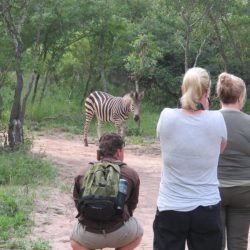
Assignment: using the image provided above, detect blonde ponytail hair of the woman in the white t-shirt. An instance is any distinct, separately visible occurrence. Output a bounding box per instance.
[181,67,211,110]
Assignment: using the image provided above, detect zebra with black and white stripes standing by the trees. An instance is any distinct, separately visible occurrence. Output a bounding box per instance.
[83,91,144,147]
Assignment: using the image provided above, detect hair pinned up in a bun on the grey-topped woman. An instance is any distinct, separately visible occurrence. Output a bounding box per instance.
[216,72,246,104]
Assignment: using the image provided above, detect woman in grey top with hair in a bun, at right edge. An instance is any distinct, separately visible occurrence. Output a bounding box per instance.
[217,73,250,250]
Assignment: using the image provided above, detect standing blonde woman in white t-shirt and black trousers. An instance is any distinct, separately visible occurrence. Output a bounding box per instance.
[153,67,227,250]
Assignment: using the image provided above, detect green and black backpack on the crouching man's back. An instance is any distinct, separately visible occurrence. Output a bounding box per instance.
[78,162,120,221]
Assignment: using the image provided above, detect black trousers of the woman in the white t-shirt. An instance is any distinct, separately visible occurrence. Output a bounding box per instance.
[153,203,222,250]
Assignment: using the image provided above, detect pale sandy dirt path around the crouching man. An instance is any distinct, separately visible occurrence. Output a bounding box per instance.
[31,133,161,250]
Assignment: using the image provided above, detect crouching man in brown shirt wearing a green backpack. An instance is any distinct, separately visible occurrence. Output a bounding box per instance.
[70,133,143,250]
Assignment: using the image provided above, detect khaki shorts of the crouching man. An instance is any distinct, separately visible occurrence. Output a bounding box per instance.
[70,217,143,249]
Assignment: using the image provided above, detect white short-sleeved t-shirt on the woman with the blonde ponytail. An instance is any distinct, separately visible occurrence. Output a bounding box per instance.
[157,108,227,211]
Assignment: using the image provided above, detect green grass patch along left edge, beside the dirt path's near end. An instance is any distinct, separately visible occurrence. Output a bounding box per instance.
[0,146,55,244]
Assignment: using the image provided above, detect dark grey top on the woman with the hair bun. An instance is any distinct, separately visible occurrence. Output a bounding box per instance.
[218,109,250,187]
